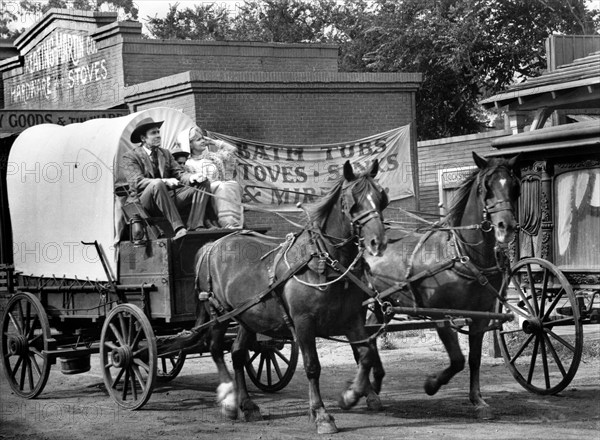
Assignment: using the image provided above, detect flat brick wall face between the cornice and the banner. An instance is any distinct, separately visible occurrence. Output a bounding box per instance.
[195,92,411,144]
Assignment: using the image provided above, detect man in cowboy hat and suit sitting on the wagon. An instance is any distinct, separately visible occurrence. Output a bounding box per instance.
[123,118,208,239]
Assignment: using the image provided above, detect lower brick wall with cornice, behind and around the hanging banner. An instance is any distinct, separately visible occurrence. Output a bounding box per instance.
[126,71,420,236]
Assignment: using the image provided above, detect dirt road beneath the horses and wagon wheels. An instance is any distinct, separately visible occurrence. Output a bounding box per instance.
[0,338,600,440]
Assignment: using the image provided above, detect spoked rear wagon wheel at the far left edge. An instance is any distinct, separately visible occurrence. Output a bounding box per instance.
[0,293,51,399]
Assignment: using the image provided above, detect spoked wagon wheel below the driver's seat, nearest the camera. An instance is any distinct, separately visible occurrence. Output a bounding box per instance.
[100,304,157,410]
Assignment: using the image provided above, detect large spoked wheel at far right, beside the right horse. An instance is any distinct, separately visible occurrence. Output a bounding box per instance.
[496,258,583,394]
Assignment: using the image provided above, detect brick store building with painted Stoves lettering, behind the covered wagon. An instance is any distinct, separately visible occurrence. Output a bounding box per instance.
[0,9,421,254]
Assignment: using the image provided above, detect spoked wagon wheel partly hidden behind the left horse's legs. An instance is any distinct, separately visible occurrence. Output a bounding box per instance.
[246,339,298,393]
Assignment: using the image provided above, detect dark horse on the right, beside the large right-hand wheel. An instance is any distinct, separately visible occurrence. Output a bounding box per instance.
[366,153,520,418]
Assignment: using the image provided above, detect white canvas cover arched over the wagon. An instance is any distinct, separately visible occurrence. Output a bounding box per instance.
[7,107,195,281]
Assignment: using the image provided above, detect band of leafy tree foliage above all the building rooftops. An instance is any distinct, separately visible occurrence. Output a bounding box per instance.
[5,0,600,139]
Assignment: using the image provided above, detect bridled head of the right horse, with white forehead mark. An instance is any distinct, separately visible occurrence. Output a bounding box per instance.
[473,152,521,243]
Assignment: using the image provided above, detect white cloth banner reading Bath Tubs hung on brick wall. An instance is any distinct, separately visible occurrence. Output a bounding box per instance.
[212,125,414,209]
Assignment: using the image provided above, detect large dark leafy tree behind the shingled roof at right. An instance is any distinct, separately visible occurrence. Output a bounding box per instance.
[332,0,598,139]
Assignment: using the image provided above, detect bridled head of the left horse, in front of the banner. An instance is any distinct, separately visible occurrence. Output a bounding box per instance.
[341,160,388,256]
